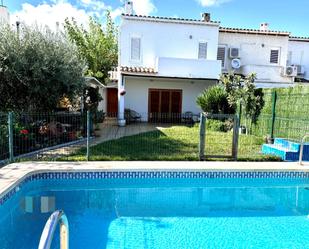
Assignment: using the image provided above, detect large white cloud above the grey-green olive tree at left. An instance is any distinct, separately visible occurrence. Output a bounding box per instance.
[11,0,89,29]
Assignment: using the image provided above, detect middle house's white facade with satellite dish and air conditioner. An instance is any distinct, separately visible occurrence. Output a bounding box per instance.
[218,24,294,83]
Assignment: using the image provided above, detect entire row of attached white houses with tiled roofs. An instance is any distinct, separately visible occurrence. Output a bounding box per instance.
[105,1,309,125]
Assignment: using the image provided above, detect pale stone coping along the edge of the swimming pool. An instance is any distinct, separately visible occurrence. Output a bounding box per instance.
[0,161,309,198]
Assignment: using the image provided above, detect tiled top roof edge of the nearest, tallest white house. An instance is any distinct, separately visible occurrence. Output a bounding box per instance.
[122,14,220,25]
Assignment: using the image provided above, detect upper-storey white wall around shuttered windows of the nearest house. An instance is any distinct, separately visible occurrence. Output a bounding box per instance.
[119,17,218,78]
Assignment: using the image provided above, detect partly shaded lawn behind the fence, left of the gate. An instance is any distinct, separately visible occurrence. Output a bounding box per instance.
[68,130,198,161]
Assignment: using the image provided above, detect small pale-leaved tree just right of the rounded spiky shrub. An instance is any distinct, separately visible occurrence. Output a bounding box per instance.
[220,73,264,123]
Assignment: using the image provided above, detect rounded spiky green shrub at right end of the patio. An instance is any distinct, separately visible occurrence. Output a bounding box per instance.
[196,85,235,114]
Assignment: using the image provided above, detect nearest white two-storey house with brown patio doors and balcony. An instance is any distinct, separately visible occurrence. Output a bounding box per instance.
[114,6,221,124]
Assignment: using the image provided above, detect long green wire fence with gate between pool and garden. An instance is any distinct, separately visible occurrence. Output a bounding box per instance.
[0,106,309,163]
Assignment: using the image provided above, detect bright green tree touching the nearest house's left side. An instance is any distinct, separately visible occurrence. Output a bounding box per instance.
[65,11,118,83]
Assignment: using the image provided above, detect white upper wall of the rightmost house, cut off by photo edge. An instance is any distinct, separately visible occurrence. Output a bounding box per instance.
[289,41,309,80]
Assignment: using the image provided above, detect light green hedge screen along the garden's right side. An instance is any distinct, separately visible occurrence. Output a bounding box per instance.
[241,86,309,141]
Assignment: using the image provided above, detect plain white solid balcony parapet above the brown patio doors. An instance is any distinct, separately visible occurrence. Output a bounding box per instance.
[157,57,221,79]
